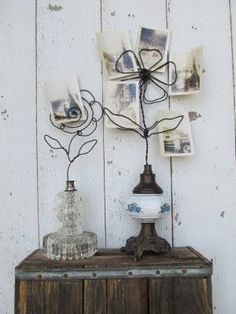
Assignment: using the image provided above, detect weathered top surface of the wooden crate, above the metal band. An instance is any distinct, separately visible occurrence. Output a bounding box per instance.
[16,248,211,272]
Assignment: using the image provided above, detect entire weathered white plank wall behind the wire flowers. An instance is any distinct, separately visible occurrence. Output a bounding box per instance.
[0,0,236,314]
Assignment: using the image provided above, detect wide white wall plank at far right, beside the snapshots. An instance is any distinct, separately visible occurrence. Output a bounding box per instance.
[169,0,236,314]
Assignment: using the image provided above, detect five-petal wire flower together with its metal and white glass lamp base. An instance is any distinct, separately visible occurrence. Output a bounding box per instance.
[101,49,184,260]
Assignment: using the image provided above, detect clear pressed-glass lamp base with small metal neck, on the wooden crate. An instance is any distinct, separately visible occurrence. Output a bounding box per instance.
[43,181,97,260]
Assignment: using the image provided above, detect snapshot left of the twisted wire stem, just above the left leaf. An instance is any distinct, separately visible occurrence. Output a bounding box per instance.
[105,81,139,129]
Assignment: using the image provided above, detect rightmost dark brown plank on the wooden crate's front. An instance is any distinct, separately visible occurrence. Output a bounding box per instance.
[149,277,212,314]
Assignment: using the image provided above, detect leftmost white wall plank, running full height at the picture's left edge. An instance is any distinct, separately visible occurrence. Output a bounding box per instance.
[0,0,38,314]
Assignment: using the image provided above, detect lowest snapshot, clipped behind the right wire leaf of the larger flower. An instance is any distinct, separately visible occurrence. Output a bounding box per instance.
[158,110,194,157]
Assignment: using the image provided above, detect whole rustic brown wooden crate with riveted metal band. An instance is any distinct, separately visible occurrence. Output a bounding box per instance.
[15,247,212,314]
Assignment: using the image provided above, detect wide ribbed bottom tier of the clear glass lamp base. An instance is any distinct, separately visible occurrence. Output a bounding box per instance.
[43,231,97,260]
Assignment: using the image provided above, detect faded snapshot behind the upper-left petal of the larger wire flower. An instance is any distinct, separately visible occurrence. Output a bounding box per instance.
[97,31,137,79]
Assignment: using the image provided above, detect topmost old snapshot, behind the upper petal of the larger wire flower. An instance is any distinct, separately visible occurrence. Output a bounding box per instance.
[137,27,170,72]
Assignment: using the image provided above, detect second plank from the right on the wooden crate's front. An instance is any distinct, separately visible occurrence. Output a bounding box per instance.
[107,279,148,314]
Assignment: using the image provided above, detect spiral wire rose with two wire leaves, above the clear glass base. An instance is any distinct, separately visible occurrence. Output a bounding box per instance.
[44,89,103,181]
